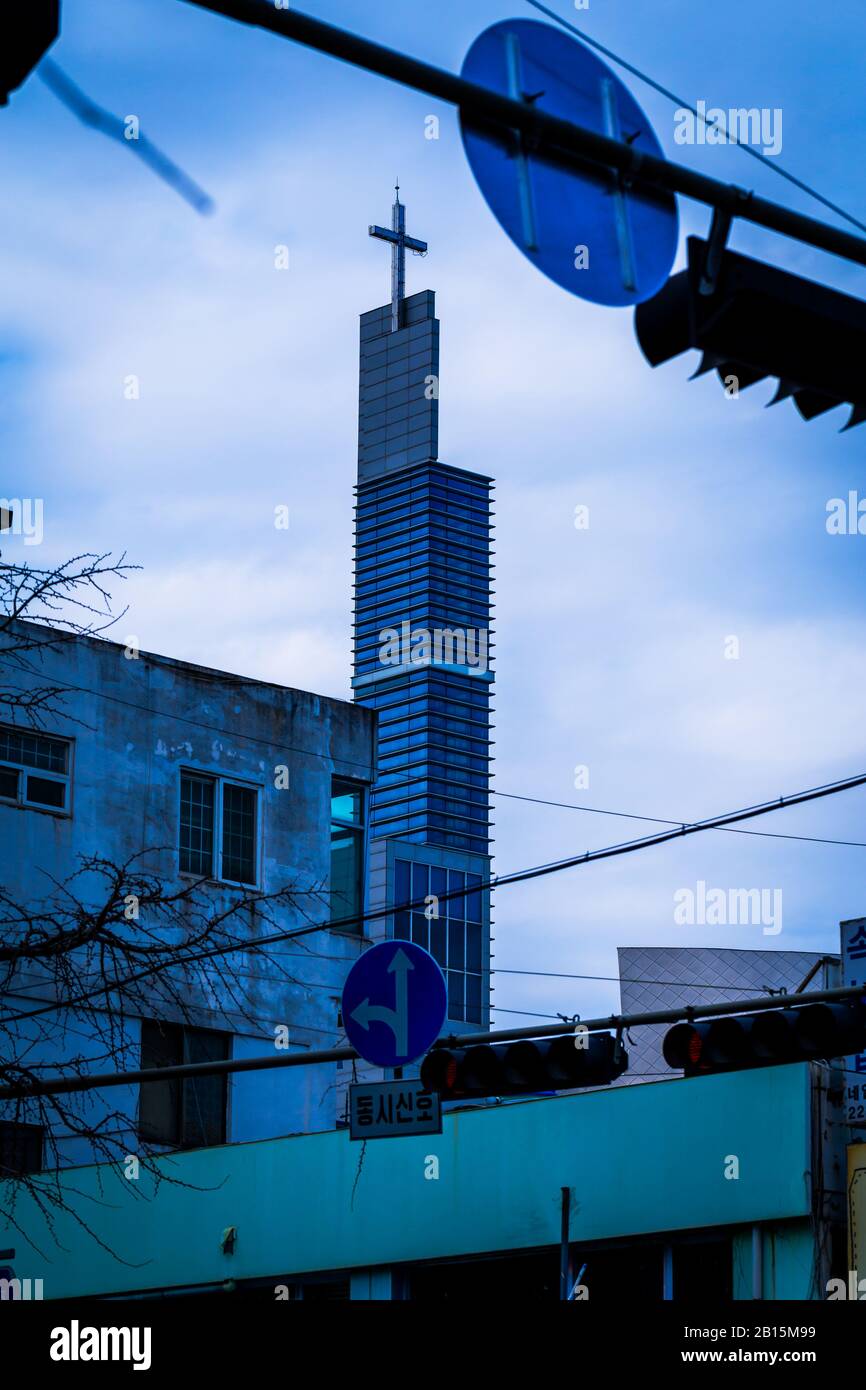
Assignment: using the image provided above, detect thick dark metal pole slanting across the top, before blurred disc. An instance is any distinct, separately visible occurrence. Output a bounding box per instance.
[177,0,866,265]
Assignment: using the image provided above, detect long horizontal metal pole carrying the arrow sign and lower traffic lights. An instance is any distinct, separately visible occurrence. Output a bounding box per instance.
[0,986,866,1101]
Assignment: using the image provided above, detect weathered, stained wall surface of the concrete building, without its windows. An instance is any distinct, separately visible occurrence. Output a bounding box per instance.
[0,622,375,1162]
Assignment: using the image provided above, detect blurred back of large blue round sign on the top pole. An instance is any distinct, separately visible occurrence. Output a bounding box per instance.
[460,19,678,306]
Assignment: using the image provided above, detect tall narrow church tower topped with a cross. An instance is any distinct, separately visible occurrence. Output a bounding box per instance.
[352,188,493,1030]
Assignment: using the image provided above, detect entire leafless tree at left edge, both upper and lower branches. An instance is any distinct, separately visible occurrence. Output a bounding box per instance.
[0,553,333,1264]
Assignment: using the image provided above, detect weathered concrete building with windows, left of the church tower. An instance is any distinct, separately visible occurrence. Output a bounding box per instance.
[0,630,375,1166]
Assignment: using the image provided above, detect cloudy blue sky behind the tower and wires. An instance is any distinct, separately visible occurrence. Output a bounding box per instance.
[0,0,866,1022]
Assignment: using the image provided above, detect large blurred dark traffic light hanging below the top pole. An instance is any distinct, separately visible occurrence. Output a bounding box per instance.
[635,236,866,430]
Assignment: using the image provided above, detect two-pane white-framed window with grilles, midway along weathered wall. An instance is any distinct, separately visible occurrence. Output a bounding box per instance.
[179,771,259,884]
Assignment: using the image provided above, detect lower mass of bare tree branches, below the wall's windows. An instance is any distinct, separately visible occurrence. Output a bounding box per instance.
[0,852,324,1259]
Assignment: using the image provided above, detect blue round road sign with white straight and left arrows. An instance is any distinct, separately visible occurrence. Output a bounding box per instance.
[342,941,448,1066]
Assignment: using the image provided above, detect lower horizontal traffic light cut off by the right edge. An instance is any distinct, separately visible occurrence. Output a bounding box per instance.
[662,999,866,1076]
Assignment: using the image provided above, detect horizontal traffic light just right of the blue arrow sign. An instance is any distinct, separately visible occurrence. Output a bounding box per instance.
[421,1029,628,1101]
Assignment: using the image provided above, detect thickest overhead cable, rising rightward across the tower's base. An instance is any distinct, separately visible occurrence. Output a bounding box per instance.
[6,773,866,1022]
